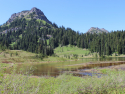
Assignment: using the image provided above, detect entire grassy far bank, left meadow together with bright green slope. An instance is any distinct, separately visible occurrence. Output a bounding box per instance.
[0,45,122,65]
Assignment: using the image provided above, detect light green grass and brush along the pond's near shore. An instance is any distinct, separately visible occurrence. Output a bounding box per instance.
[0,70,125,94]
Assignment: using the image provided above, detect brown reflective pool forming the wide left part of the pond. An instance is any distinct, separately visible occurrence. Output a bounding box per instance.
[4,64,60,76]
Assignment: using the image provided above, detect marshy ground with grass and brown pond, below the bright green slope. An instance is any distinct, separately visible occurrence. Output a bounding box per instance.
[0,50,125,94]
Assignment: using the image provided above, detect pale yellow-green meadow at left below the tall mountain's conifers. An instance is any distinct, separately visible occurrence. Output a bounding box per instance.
[0,50,41,63]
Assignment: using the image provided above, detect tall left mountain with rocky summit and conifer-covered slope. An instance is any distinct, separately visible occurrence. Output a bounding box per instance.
[0,7,57,55]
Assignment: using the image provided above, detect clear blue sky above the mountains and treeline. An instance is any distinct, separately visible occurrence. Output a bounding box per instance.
[0,0,125,33]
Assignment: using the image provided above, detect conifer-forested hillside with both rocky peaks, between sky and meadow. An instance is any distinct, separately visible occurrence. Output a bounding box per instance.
[0,7,125,58]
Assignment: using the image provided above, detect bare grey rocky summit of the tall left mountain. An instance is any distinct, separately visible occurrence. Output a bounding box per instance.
[7,7,51,24]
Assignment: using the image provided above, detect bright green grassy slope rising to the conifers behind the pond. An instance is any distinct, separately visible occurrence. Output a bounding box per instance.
[43,45,93,61]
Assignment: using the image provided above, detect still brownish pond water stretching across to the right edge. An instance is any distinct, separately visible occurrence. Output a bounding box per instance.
[4,57,125,77]
